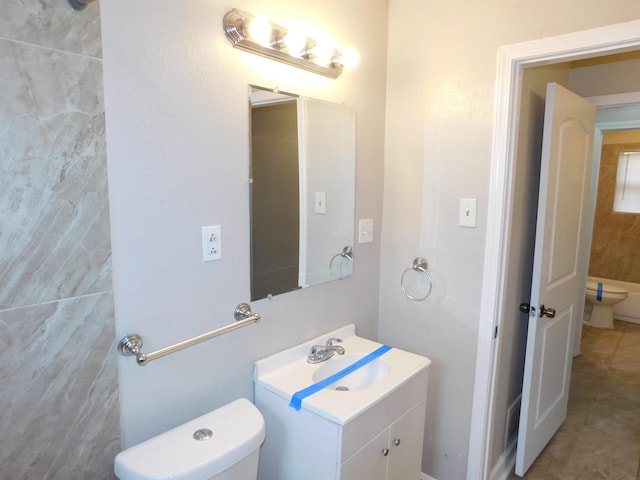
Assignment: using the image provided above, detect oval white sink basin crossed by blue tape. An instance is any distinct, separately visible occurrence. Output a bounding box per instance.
[312,353,391,392]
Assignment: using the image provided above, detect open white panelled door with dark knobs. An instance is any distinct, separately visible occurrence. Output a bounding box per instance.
[516,83,596,476]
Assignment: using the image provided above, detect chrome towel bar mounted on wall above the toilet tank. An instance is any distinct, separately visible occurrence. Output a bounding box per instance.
[118,303,260,365]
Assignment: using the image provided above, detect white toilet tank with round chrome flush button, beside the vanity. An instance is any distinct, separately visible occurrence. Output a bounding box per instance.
[114,398,265,480]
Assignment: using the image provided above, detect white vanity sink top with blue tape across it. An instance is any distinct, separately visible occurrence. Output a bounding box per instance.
[254,324,431,425]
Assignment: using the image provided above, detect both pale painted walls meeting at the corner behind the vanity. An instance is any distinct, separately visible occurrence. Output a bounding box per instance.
[101,0,640,474]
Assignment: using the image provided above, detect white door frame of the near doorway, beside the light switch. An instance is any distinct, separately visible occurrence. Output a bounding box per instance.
[467,20,640,480]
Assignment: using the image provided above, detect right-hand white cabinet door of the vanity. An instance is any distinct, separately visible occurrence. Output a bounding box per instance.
[387,399,427,480]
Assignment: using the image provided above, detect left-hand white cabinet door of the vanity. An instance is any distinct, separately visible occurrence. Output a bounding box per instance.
[340,429,390,480]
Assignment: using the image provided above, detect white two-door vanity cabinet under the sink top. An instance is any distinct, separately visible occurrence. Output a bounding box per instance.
[255,368,428,480]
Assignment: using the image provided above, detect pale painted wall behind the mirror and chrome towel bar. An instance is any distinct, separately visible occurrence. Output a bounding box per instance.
[101,0,387,446]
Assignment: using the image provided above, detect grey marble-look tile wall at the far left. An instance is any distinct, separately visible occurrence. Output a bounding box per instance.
[0,0,120,480]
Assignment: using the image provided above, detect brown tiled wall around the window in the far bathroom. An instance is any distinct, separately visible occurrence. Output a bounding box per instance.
[589,139,640,283]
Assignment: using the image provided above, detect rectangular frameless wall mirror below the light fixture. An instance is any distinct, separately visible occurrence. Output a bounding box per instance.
[249,86,355,301]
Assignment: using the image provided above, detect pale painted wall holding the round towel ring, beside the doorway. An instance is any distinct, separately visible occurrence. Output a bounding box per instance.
[380,0,640,480]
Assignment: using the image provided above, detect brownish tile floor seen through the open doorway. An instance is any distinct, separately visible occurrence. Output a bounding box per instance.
[509,321,640,480]
